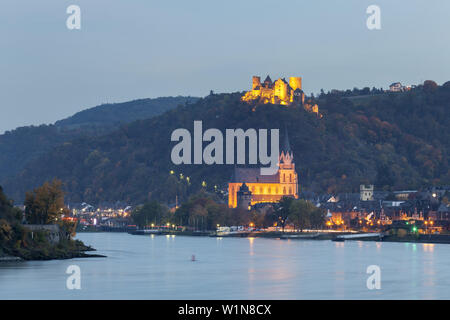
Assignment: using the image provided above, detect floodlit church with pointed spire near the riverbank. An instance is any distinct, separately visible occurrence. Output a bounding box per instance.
[228,132,298,209]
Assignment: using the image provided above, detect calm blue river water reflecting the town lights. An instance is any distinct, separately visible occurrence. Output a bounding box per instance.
[0,233,450,299]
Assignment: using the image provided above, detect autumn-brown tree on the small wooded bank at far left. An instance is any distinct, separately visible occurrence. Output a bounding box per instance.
[24,179,65,224]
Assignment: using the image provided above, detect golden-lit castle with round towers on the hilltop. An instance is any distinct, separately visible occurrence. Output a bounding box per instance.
[241,76,320,116]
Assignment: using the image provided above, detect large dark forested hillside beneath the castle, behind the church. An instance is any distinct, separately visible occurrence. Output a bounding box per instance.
[4,85,450,203]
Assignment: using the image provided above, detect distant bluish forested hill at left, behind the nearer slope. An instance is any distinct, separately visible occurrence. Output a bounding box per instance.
[0,96,198,183]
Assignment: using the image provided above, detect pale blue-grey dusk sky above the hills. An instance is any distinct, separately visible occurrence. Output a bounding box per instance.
[0,0,450,133]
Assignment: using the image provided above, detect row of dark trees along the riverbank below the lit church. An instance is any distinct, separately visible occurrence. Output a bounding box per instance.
[132,192,325,231]
